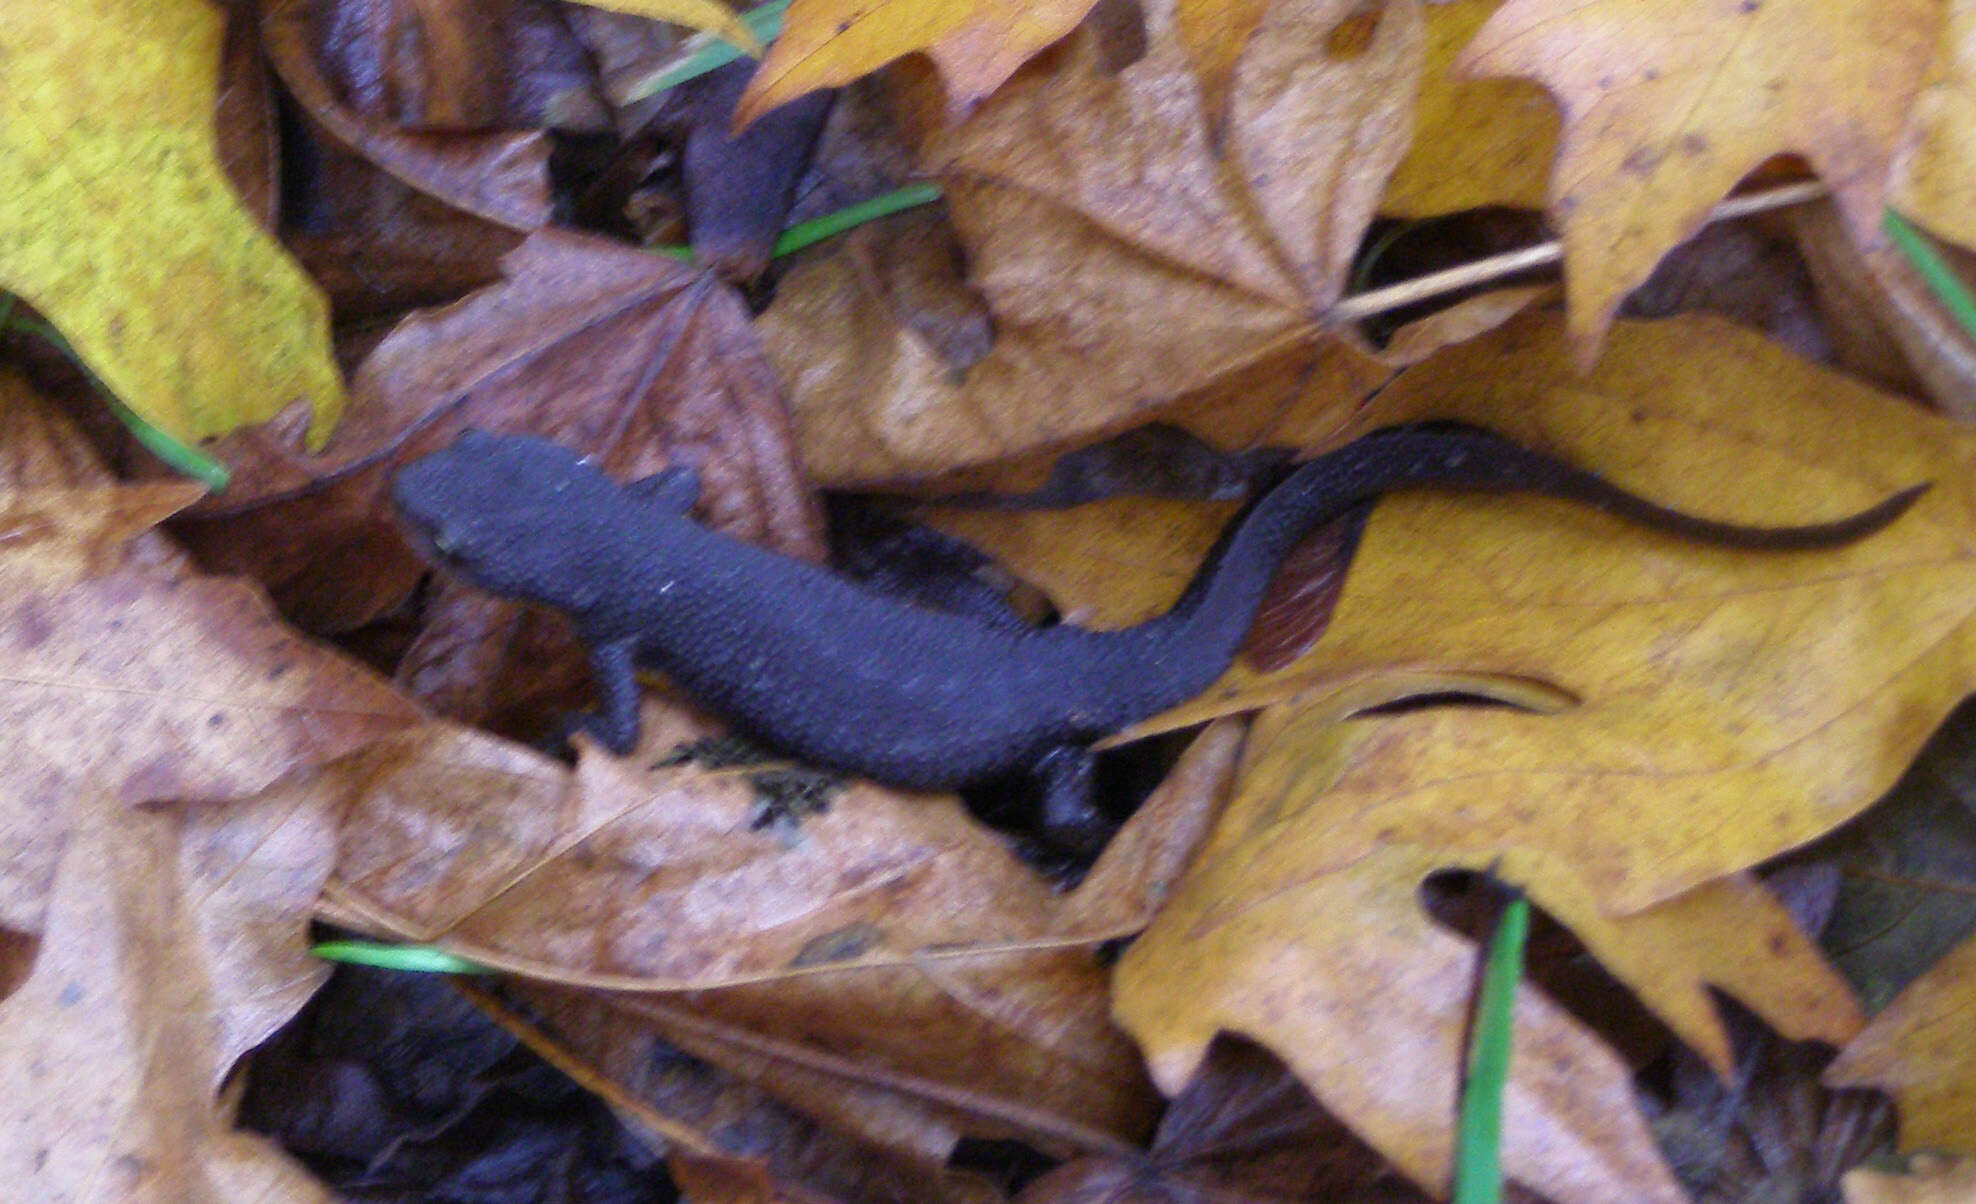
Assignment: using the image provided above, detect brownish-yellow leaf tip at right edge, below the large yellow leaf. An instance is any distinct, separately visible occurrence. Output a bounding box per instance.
[1826,925,1976,1155]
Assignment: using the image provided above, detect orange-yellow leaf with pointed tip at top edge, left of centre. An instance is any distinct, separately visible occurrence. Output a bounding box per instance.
[735,0,1097,125]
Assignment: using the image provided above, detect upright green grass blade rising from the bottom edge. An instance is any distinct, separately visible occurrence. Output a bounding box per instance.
[1454,894,1529,1204]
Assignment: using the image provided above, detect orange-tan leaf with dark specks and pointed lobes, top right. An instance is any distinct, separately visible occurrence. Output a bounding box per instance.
[1460,0,1942,366]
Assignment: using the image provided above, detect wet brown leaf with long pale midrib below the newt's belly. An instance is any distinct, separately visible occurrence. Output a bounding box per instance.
[326,706,1239,1149]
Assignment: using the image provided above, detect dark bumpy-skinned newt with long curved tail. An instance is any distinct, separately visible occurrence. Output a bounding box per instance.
[393,427,1927,836]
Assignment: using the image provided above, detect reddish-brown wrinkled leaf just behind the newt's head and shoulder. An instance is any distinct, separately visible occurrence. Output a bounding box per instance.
[354,231,822,558]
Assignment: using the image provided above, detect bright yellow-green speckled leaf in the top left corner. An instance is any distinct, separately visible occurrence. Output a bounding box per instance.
[0,0,342,439]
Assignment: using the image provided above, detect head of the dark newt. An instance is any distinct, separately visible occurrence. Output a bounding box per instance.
[391,429,624,605]
